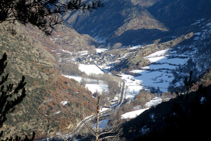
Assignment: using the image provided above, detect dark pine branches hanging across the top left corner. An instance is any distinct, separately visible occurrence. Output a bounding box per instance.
[0,0,104,35]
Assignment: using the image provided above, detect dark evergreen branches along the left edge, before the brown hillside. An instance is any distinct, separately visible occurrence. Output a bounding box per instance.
[0,53,35,141]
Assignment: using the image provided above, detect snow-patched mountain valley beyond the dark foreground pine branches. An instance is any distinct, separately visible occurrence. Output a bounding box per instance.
[0,0,211,140]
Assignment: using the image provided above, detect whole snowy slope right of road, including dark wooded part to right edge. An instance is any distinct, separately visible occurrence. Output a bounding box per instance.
[121,20,211,94]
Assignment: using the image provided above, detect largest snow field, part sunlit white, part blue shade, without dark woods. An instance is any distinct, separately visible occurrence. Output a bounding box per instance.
[118,49,191,98]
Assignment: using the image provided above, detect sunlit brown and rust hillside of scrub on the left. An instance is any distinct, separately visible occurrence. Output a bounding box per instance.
[0,23,95,138]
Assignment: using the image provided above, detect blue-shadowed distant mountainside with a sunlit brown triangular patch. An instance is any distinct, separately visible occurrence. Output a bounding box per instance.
[63,0,211,46]
